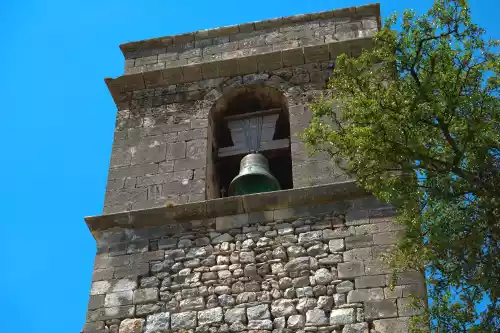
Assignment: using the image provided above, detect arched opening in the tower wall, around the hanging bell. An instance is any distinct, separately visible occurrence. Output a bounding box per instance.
[207,85,293,199]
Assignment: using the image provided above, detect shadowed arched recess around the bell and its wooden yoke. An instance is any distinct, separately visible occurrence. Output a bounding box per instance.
[206,82,293,199]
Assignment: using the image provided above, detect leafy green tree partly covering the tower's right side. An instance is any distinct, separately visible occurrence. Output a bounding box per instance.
[302,0,500,332]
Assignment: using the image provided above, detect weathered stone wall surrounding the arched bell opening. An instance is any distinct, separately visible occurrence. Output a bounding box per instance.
[104,61,345,213]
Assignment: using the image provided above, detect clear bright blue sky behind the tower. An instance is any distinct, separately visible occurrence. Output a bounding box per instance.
[0,0,500,333]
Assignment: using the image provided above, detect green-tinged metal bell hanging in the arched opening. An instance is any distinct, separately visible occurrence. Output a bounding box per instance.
[229,154,280,196]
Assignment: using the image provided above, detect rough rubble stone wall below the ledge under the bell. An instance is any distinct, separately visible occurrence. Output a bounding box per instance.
[83,197,425,333]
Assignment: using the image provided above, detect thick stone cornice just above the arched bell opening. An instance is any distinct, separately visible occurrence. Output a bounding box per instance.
[104,37,372,101]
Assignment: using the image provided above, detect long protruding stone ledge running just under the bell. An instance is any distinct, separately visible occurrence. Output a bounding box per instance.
[85,181,369,236]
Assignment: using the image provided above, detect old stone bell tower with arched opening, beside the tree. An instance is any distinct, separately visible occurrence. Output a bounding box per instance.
[83,4,425,333]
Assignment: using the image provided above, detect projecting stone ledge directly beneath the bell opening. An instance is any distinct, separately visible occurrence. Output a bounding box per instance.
[85,181,368,236]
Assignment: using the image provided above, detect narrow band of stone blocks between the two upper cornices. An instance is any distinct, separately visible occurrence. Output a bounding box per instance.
[124,11,378,74]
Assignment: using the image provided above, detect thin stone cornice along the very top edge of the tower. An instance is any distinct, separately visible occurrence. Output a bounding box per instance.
[120,3,380,55]
